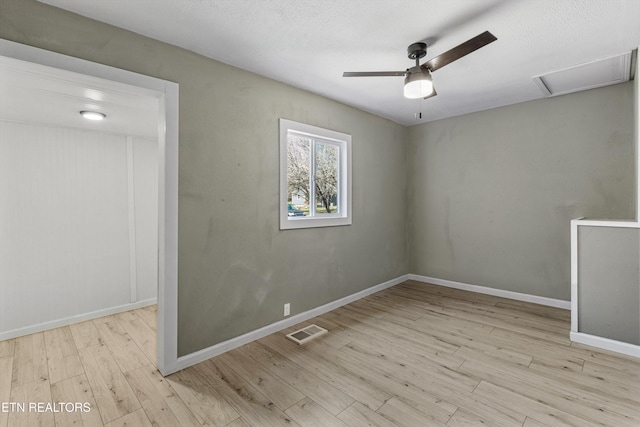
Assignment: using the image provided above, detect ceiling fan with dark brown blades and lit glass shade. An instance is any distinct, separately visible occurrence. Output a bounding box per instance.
[342,31,498,99]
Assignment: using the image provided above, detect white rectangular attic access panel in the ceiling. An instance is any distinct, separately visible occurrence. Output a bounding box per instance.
[531,51,634,97]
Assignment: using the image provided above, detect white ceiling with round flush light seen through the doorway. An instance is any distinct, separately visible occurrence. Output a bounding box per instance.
[0,57,159,138]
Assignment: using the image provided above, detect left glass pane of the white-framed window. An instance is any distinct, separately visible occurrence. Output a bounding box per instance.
[287,133,311,217]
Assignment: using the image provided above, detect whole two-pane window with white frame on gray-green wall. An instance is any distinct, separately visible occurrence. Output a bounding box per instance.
[280,119,351,230]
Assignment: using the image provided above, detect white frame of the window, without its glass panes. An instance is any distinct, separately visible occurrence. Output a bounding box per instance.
[280,119,351,230]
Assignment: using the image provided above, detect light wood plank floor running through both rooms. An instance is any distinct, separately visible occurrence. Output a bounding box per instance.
[0,281,640,427]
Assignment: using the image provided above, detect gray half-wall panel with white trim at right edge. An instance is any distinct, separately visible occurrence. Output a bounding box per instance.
[578,226,640,345]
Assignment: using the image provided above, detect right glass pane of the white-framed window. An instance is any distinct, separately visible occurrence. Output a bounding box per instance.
[315,142,339,215]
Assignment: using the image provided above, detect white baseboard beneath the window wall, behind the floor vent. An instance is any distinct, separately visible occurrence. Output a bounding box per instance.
[170,274,409,375]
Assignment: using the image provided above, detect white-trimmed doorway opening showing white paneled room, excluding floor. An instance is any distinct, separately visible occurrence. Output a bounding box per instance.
[0,40,178,375]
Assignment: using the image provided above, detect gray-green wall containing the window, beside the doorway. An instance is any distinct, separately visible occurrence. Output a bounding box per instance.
[0,0,409,355]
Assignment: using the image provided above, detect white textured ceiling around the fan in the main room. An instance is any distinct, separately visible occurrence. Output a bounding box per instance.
[28,0,640,125]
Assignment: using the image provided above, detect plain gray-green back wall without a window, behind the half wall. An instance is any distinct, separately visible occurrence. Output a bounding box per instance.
[408,83,635,300]
